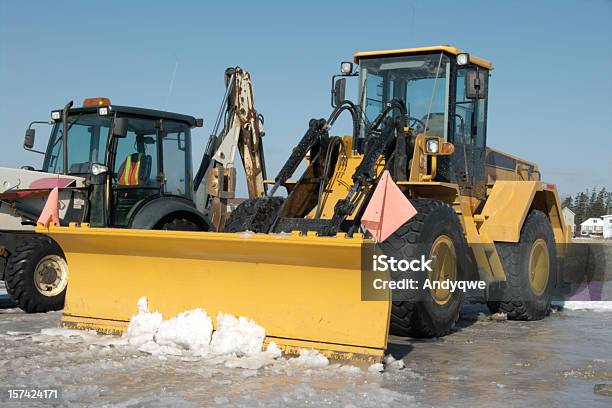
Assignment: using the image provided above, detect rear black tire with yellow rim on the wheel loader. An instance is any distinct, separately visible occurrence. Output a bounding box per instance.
[488,210,558,320]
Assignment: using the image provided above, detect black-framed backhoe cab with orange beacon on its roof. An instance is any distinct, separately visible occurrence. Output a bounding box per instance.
[43,98,201,227]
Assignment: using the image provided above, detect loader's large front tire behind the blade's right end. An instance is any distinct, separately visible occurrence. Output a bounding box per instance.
[381,199,467,338]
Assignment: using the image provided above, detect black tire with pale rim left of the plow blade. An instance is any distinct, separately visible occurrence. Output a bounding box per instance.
[5,236,68,313]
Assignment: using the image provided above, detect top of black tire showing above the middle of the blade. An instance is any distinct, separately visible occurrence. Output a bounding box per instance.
[224,197,285,233]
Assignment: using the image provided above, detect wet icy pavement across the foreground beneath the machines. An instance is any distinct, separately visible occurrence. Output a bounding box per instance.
[0,286,612,408]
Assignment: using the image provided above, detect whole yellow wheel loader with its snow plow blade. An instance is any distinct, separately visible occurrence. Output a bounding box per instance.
[40,46,569,362]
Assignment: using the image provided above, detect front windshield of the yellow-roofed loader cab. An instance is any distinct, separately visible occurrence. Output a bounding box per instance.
[359,53,451,139]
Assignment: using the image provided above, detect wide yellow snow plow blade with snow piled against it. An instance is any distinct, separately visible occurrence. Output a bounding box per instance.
[38,225,390,362]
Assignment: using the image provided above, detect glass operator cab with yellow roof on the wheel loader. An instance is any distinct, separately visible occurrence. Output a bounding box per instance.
[343,46,493,195]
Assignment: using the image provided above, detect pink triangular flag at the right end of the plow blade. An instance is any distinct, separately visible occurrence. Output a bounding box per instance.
[361,170,417,242]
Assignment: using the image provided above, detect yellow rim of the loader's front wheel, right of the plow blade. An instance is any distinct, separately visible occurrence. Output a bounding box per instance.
[428,235,457,305]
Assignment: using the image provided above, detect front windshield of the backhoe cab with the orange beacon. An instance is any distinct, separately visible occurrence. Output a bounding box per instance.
[43,113,111,174]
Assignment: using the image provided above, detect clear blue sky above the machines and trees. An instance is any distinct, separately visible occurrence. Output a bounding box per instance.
[0,0,612,194]
